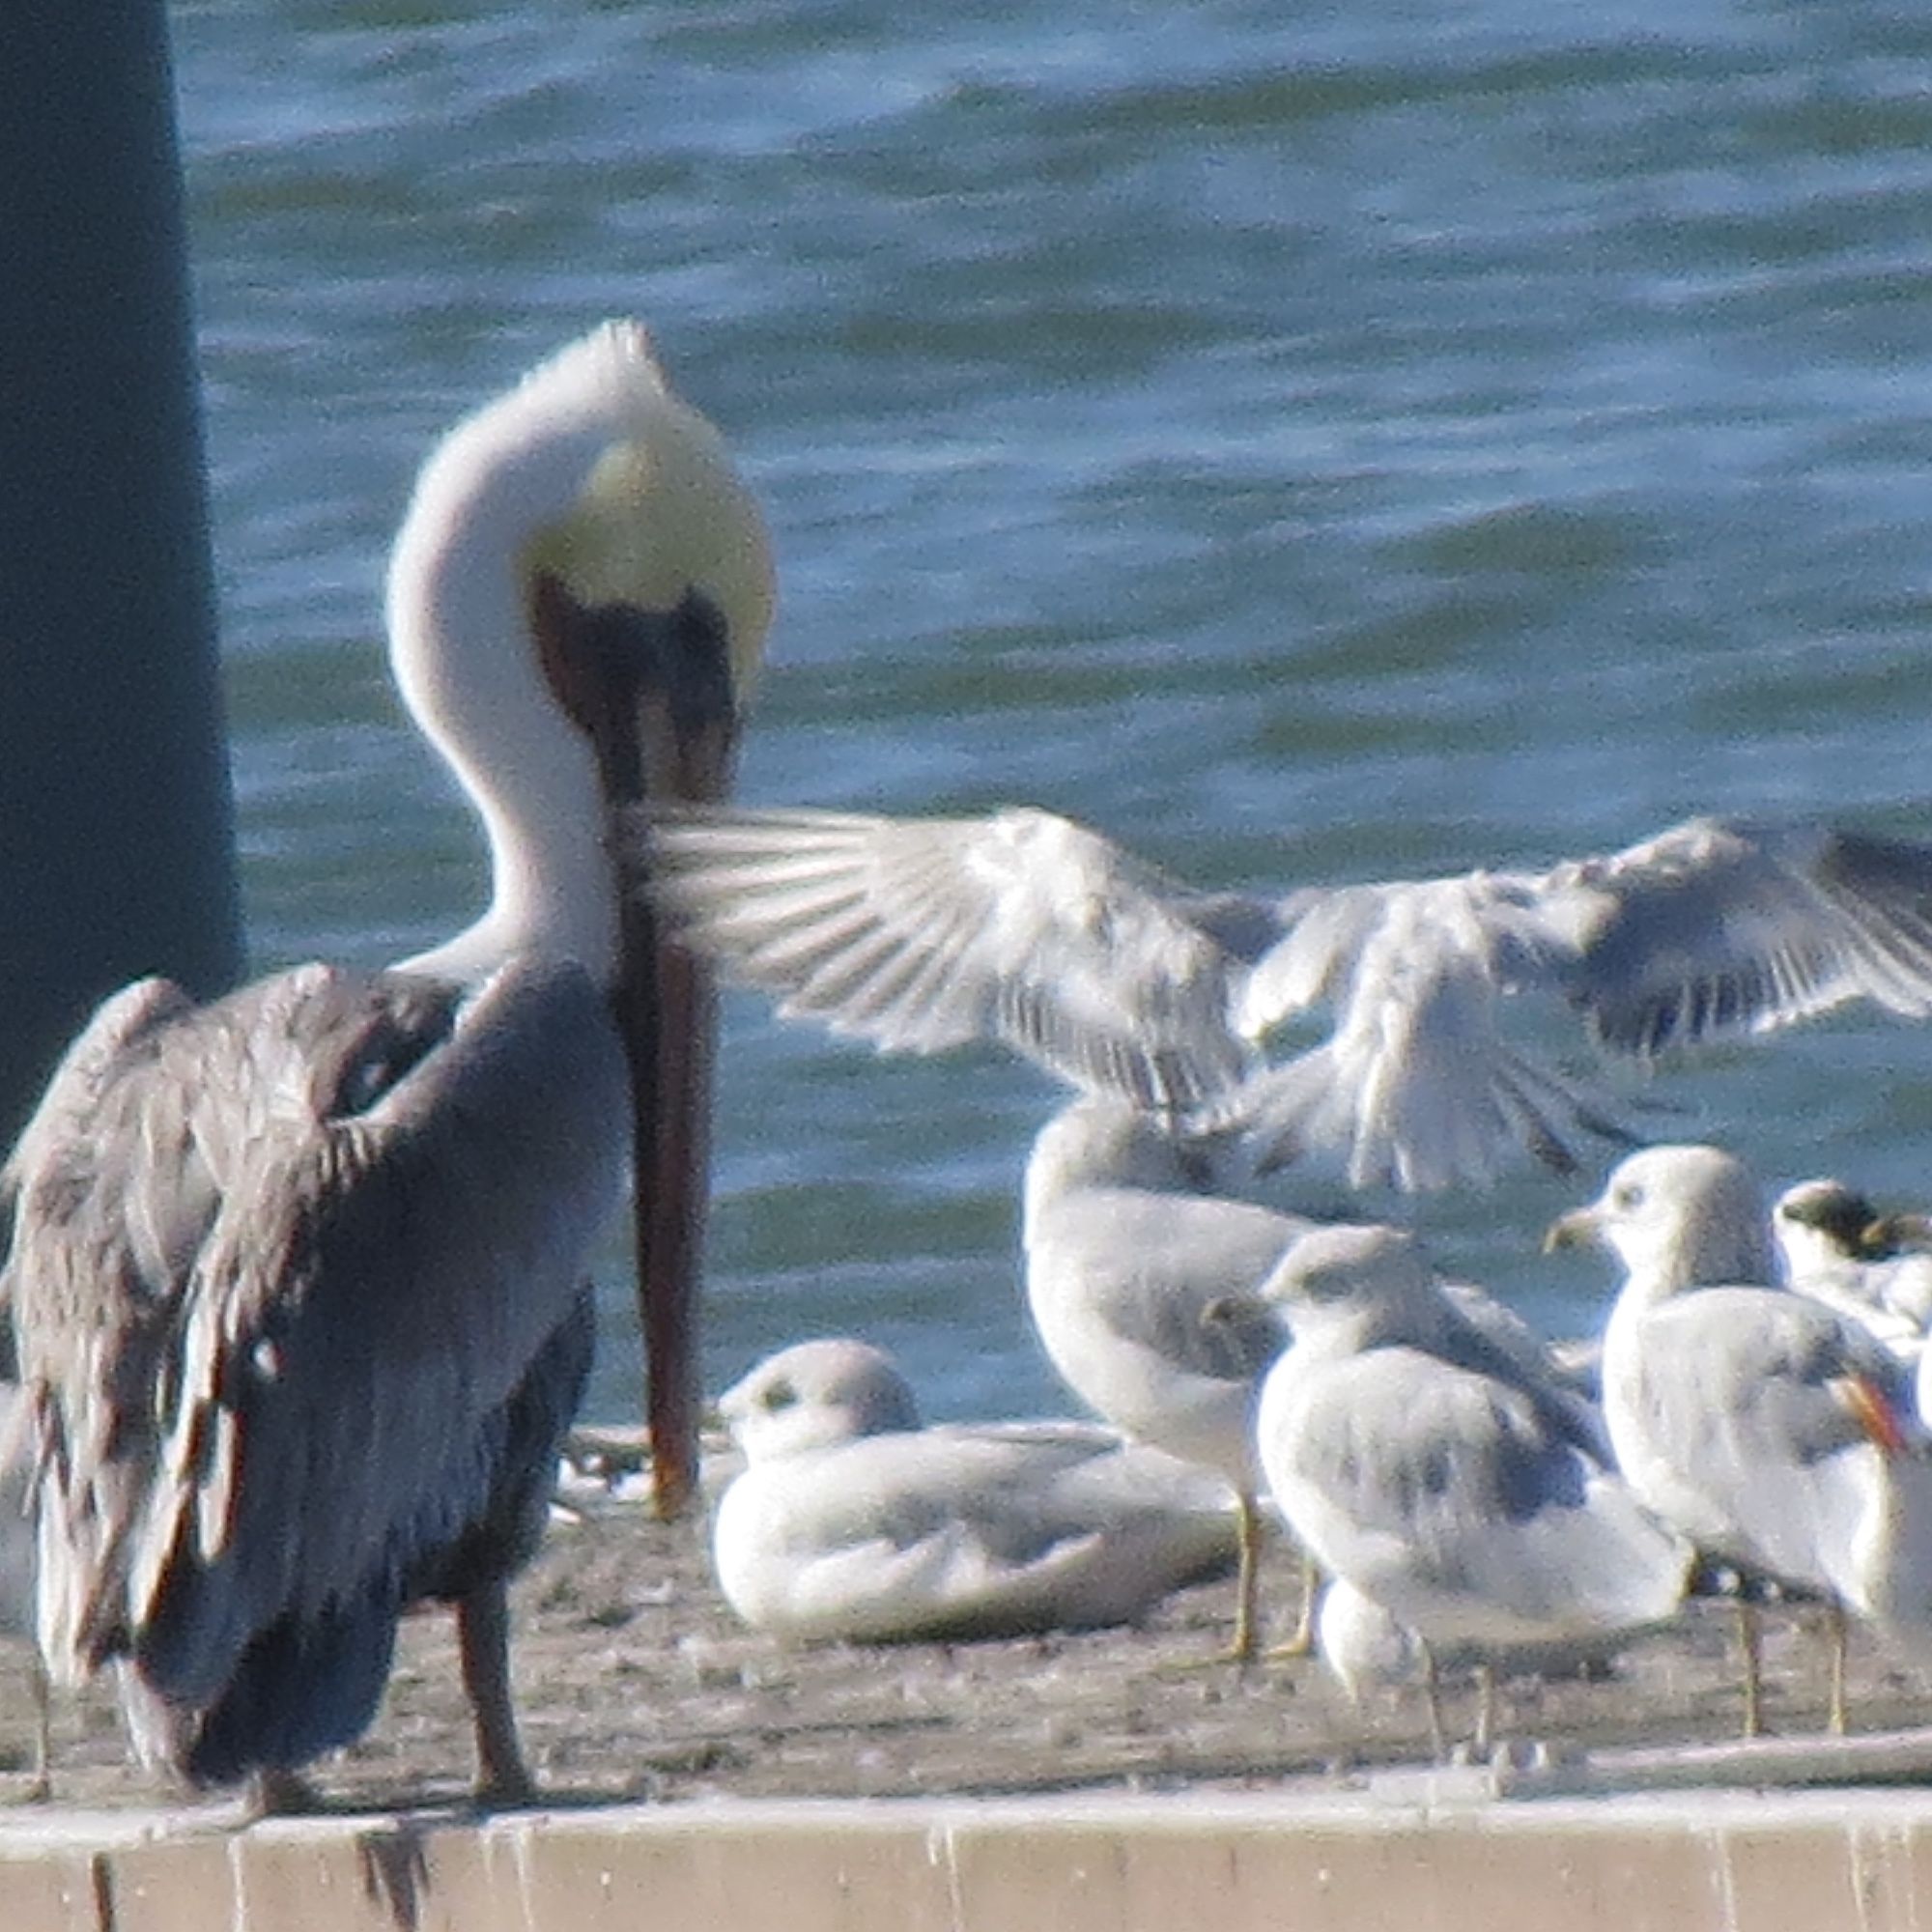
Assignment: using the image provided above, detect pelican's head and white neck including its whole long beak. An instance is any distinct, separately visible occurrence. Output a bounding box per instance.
[388,323,773,1515]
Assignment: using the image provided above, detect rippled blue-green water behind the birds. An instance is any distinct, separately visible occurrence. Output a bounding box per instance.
[174,0,1932,1416]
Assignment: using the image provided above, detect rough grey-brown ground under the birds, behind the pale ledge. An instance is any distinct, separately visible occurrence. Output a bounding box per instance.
[11,1453,1932,1810]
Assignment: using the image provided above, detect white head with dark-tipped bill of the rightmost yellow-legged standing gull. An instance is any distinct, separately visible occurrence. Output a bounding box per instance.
[1544,1146,1779,1296]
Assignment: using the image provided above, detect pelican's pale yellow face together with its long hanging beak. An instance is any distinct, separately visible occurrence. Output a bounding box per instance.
[529,332,773,1517]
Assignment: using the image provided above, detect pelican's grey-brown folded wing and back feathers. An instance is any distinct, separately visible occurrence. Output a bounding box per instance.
[6,964,622,1731]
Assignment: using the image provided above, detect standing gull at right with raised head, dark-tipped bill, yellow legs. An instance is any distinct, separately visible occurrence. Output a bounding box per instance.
[1549,1146,1932,1735]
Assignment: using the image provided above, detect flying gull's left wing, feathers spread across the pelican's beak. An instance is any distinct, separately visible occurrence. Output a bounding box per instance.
[641,810,1246,1109]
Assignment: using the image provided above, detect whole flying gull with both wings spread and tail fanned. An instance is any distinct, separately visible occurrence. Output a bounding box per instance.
[639,808,1932,1190]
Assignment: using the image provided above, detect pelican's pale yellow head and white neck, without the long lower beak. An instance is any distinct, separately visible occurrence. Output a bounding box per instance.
[388,323,773,980]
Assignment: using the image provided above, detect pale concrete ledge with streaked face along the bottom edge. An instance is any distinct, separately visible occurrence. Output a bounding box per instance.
[0,1783,1932,1932]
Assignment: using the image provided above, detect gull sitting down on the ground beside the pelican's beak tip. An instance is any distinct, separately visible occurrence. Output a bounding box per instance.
[711,1341,1235,1642]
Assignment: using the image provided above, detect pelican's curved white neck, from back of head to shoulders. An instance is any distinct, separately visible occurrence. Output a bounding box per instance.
[388,431,618,983]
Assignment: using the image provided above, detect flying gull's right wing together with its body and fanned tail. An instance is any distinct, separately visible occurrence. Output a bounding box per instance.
[1217,819,1932,1188]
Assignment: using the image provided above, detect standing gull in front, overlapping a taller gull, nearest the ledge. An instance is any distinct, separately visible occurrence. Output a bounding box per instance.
[1221,1227,1692,1750]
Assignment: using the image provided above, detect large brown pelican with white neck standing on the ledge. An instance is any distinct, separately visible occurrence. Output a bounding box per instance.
[0,323,771,1803]
